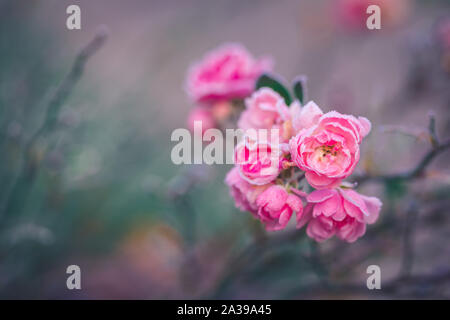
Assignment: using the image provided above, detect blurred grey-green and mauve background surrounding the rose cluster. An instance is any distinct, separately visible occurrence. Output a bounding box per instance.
[0,0,450,299]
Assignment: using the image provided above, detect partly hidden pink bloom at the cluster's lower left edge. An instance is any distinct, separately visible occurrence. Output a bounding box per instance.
[225,167,271,216]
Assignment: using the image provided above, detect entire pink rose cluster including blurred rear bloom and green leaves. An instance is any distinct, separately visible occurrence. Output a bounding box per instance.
[188,45,382,242]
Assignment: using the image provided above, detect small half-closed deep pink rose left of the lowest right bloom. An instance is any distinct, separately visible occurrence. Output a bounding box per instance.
[256,185,303,231]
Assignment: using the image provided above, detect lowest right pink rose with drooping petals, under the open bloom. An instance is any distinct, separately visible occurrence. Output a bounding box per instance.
[297,188,382,242]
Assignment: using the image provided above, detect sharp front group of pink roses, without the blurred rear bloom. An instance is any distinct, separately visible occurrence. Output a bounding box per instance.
[225,88,381,242]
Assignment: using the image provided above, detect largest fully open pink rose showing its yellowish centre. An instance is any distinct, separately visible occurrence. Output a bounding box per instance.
[289,103,371,189]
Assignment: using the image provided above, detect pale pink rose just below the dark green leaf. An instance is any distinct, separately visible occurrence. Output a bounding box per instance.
[238,88,289,130]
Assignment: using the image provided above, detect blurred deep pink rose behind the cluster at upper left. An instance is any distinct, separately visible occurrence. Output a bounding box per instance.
[186,44,272,102]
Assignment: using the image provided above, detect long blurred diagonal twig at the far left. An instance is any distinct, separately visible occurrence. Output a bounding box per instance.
[1,28,107,222]
